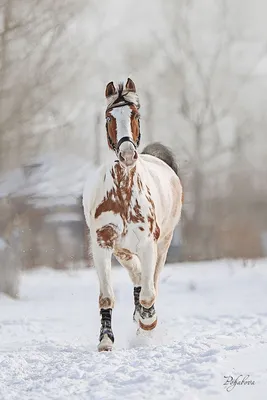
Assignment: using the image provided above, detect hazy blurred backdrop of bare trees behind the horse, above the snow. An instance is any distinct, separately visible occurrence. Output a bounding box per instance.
[0,0,267,290]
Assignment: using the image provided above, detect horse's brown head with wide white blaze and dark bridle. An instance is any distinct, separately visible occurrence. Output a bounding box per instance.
[106,78,140,167]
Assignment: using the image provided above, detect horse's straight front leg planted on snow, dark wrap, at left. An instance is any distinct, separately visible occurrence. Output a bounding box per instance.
[93,242,115,351]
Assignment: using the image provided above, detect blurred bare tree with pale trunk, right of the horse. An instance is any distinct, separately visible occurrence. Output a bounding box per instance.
[155,0,267,257]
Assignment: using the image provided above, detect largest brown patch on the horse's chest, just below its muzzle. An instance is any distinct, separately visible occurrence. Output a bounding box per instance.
[95,163,145,235]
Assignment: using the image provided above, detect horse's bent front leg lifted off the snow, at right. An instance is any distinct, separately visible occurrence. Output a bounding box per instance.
[139,241,157,330]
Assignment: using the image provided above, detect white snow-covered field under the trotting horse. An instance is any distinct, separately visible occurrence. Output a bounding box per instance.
[0,260,267,400]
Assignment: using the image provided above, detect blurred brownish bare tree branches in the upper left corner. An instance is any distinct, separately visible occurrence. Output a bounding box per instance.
[0,0,96,170]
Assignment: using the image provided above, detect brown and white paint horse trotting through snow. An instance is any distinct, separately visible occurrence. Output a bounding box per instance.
[83,78,182,351]
